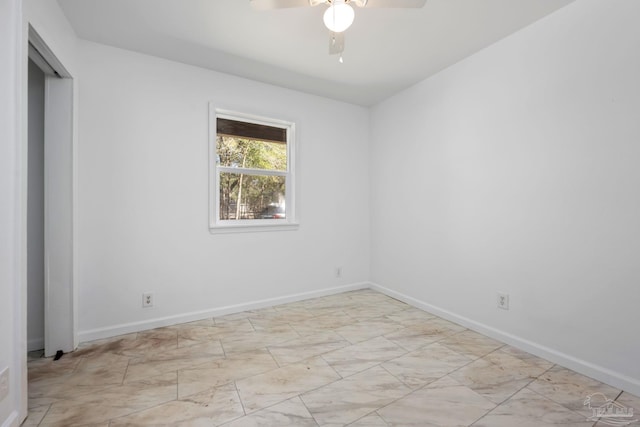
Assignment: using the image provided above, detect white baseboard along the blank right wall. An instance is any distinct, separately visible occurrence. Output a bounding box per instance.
[370,283,640,396]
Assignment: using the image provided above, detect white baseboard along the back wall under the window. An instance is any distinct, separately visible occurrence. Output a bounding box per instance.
[78,282,370,342]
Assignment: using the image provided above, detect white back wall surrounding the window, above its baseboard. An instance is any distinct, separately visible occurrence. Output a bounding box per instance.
[76,42,369,340]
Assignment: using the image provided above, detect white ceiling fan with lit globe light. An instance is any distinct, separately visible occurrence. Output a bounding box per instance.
[249,0,427,62]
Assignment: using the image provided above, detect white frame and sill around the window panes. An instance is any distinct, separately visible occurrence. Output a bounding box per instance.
[209,103,299,234]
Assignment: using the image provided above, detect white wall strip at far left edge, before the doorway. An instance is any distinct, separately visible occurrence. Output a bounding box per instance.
[0,0,26,426]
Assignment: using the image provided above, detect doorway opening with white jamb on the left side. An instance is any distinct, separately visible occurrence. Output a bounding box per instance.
[25,26,76,357]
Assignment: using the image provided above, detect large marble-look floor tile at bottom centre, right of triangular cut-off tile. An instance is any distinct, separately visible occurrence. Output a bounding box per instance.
[302,366,411,426]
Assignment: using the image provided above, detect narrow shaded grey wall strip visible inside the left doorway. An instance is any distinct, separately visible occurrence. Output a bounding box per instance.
[27,61,44,351]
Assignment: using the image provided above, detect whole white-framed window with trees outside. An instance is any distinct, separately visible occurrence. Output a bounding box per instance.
[209,107,297,232]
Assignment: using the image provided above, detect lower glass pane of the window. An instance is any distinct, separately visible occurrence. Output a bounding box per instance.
[220,172,286,220]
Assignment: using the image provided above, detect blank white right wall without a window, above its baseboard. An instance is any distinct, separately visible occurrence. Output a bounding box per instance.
[371,0,640,394]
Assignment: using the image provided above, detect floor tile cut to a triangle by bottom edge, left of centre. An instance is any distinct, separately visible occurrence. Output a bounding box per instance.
[224,397,318,427]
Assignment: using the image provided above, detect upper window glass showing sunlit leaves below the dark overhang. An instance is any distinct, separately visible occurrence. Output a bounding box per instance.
[216,136,287,171]
